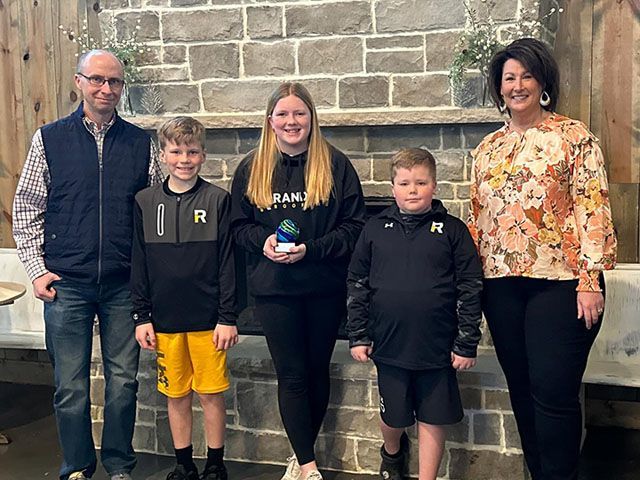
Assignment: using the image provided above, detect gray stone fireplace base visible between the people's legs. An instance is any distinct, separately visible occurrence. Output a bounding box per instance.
[92,337,526,480]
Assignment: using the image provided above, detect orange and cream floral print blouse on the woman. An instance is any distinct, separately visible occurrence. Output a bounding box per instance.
[469,113,617,291]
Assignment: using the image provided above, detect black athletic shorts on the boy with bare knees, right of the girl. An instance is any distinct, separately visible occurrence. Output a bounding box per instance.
[376,363,464,428]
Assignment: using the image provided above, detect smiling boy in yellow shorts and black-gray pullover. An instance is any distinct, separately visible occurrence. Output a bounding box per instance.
[131,117,238,480]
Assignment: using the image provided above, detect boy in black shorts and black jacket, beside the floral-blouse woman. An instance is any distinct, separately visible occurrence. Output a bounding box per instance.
[347,148,482,480]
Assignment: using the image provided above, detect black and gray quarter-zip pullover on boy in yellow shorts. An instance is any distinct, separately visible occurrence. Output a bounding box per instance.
[131,177,236,333]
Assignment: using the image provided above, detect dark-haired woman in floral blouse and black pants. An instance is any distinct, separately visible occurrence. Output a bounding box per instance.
[469,38,616,480]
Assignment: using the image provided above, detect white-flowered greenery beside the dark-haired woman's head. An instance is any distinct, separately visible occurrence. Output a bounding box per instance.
[449,0,563,105]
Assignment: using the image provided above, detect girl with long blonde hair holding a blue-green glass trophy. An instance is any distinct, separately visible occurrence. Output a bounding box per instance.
[231,83,365,480]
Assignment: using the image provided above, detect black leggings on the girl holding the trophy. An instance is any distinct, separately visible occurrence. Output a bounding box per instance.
[255,294,346,465]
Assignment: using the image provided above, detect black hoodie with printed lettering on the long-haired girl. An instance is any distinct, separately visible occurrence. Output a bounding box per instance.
[231,147,365,296]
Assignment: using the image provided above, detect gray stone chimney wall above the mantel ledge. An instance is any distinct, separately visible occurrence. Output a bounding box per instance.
[100,0,555,114]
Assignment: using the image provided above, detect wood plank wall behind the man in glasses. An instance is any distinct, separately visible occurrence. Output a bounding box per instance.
[0,0,99,247]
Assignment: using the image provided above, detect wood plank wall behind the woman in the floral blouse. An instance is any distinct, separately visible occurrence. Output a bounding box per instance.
[556,0,640,262]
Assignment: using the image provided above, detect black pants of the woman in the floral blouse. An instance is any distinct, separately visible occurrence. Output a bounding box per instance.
[483,277,604,480]
